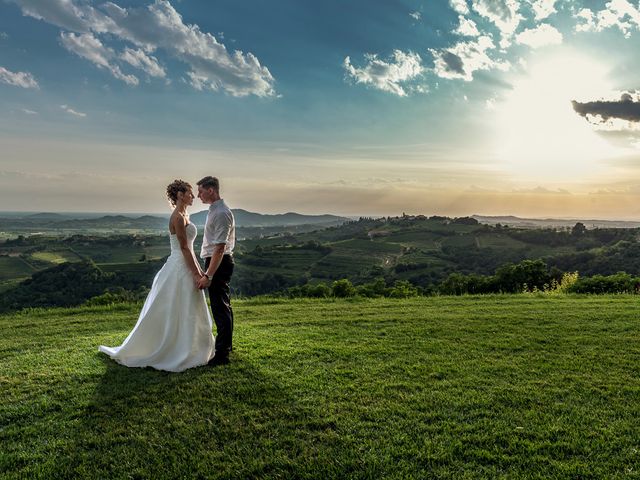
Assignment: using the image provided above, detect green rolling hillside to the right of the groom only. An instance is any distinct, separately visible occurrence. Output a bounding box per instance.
[235,217,640,294]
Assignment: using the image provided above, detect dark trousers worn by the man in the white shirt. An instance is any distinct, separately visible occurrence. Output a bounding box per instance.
[204,255,234,358]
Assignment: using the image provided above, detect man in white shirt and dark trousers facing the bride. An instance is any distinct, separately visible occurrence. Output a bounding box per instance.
[198,177,236,365]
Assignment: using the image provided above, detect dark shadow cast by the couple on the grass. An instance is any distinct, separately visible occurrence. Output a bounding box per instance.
[53,352,338,478]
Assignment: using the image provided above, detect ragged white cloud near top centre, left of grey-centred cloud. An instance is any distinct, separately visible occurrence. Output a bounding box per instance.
[343,50,423,97]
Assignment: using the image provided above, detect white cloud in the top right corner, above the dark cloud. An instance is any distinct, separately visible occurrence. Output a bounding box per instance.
[576,0,640,38]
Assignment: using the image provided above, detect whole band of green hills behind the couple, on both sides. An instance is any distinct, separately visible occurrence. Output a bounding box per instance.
[0,213,640,296]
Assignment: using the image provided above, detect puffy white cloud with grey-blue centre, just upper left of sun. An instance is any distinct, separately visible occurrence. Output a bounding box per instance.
[429,35,509,82]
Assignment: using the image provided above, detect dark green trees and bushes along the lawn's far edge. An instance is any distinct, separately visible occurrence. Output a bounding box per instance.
[0,260,640,312]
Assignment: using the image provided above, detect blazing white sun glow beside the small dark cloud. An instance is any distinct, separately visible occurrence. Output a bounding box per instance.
[494,49,619,182]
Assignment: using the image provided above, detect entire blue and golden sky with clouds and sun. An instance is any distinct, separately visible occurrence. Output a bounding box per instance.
[0,0,640,220]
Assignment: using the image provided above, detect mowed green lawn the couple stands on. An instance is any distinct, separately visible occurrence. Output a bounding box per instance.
[0,295,640,479]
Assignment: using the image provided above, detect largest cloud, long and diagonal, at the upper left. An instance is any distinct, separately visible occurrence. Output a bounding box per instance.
[10,0,276,97]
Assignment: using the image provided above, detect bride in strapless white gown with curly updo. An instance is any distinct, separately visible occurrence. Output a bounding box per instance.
[99,180,214,372]
